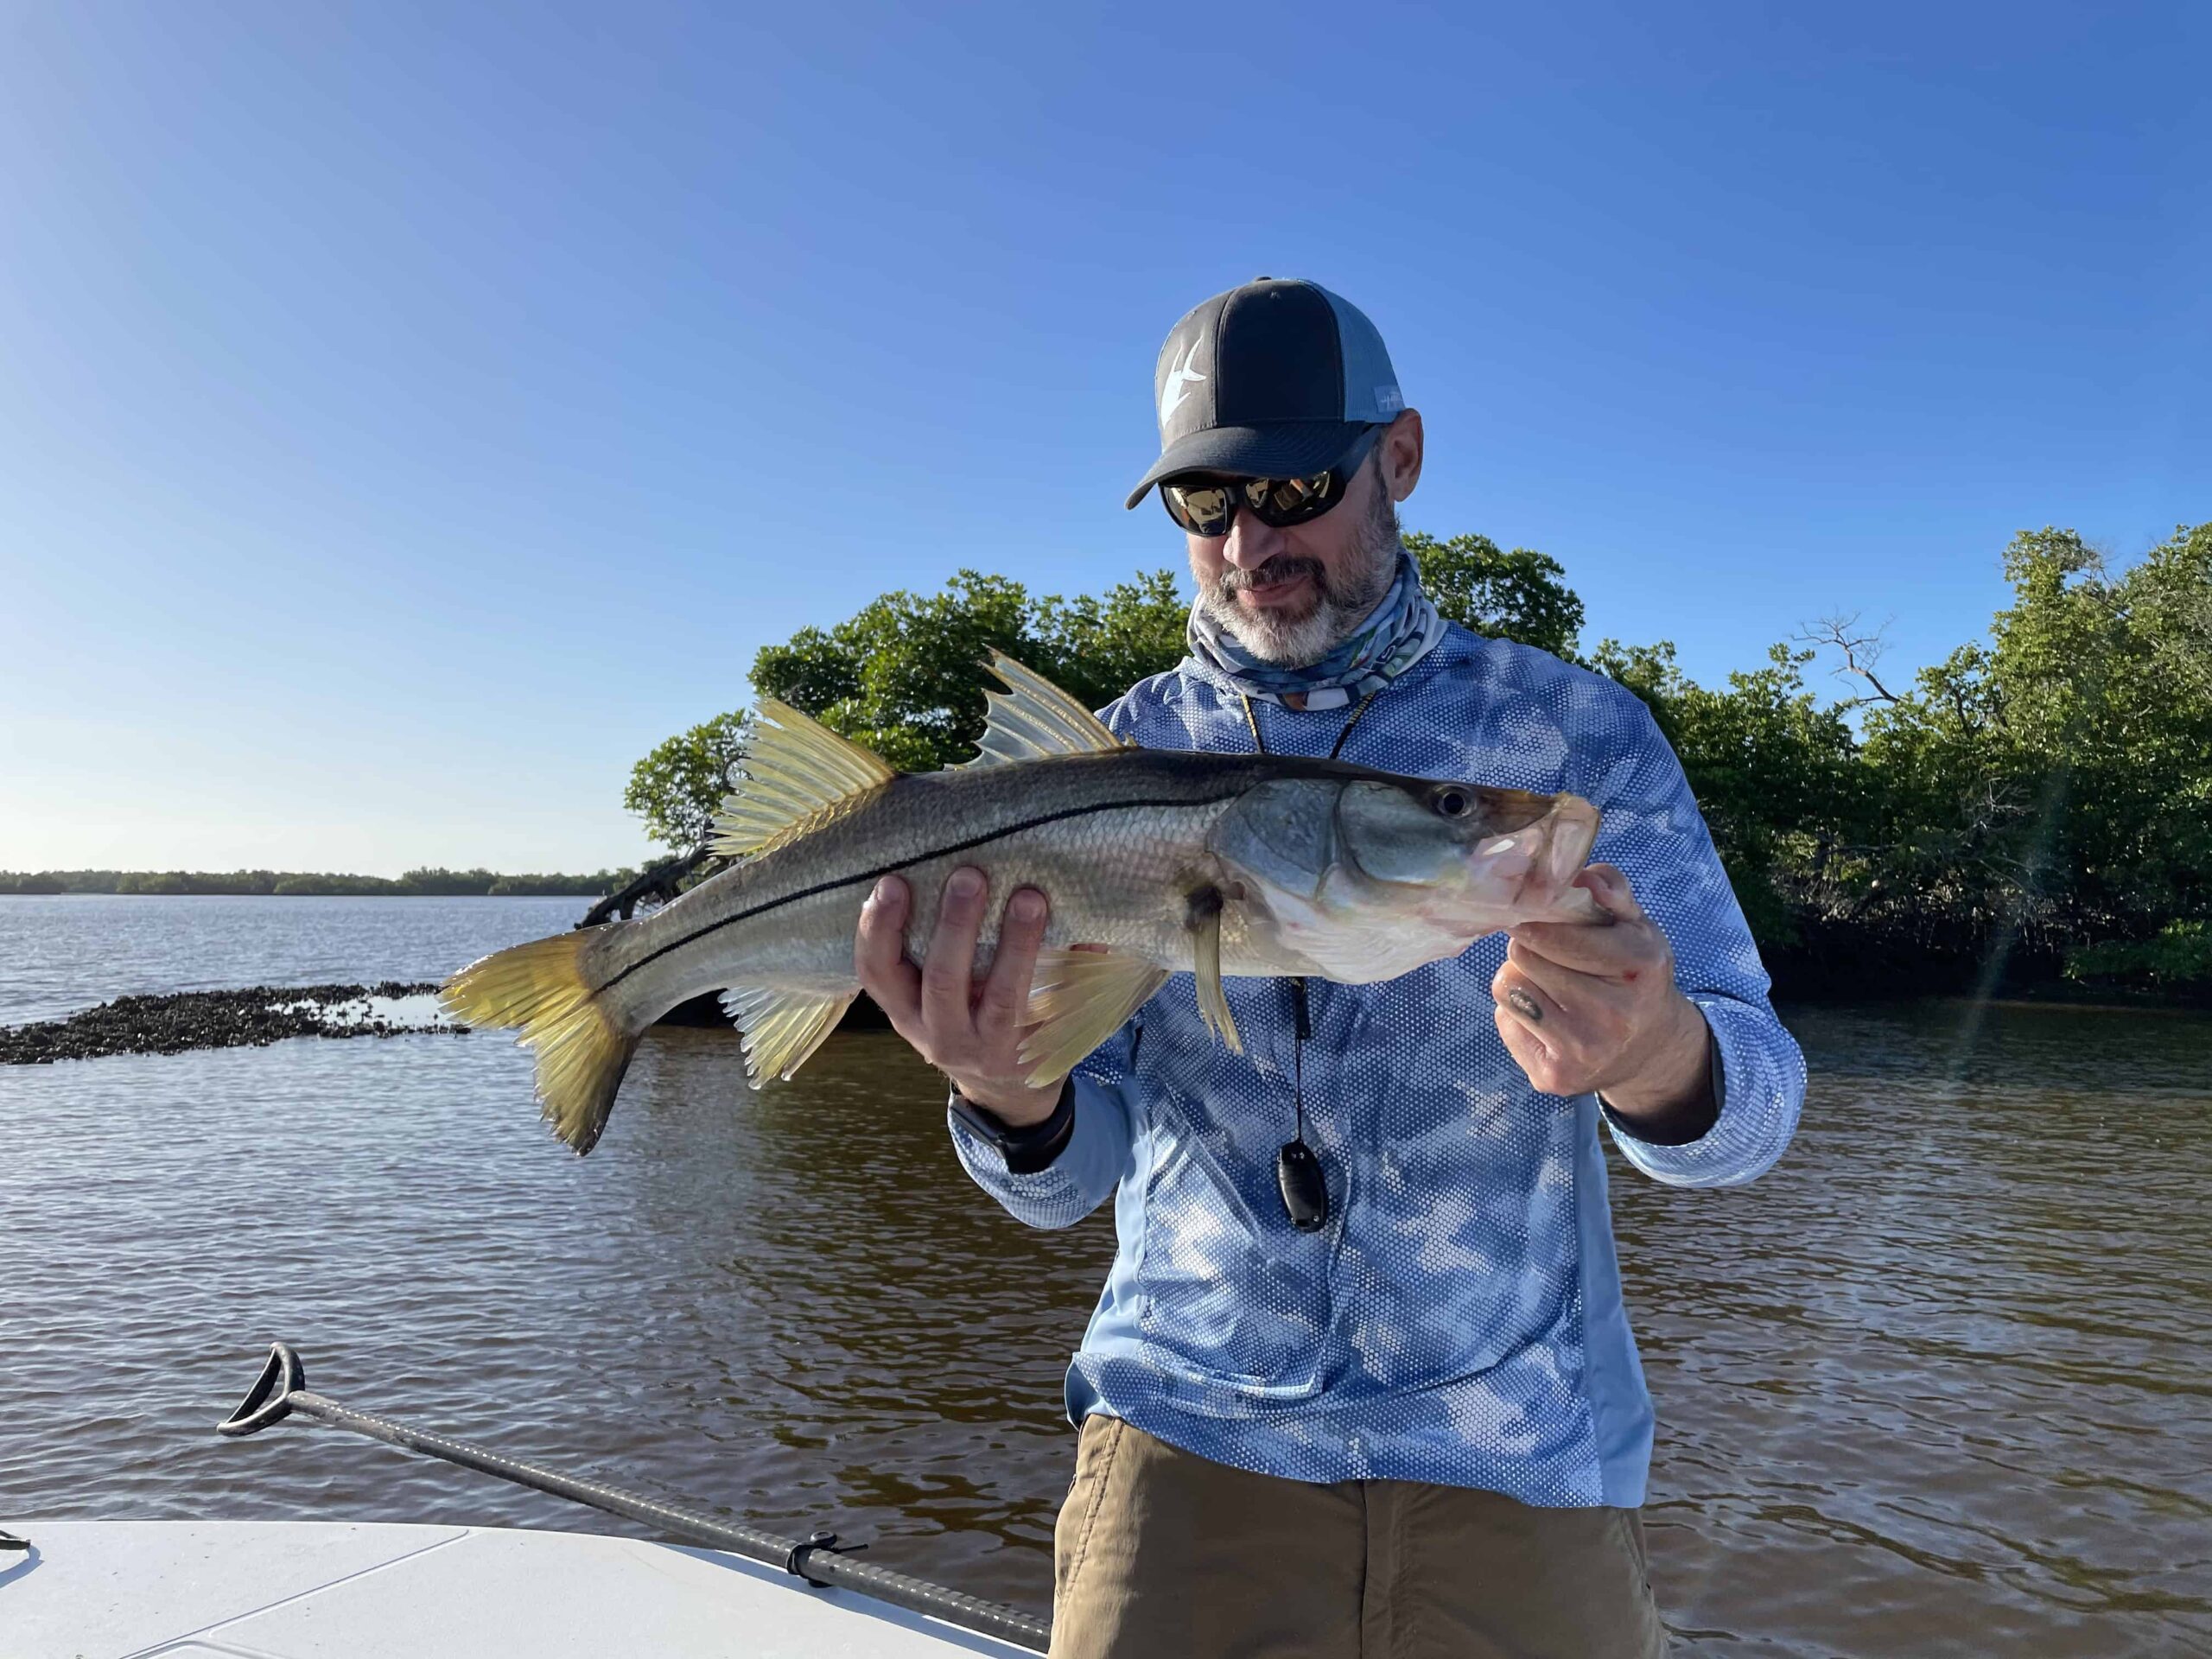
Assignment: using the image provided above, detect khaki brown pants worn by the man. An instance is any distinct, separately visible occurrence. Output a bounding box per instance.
[1053,1415,1666,1659]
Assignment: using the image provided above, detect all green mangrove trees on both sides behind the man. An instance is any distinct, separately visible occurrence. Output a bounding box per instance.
[624,512,2212,984]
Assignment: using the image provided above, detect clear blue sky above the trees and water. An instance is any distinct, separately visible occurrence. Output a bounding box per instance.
[0,0,2212,874]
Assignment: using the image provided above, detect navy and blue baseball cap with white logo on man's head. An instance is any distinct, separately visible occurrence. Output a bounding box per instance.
[1128,276,1405,506]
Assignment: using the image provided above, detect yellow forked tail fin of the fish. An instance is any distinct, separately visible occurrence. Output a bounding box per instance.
[438,929,639,1154]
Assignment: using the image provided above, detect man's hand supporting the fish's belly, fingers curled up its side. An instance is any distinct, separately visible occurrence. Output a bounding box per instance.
[852,865,1059,1128]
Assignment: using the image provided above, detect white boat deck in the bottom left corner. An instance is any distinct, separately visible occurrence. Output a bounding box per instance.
[0,1520,1028,1659]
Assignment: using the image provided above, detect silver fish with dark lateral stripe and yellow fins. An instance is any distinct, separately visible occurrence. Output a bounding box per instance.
[440,652,1612,1153]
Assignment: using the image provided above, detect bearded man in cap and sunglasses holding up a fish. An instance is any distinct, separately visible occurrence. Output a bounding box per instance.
[856,279,1805,1659]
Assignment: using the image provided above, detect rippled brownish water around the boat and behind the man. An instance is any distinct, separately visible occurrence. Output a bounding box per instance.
[0,898,2212,1659]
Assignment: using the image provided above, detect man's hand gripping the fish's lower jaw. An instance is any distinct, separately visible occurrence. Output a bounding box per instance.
[1491,865,1710,1122]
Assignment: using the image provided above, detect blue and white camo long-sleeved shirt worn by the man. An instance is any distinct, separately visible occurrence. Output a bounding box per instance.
[951,628,1805,1506]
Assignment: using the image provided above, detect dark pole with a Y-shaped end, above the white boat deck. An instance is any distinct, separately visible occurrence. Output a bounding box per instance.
[214,1343,1053,1652]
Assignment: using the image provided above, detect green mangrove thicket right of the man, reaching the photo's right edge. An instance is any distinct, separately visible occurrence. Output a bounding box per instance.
[1595,524,2212,973]
